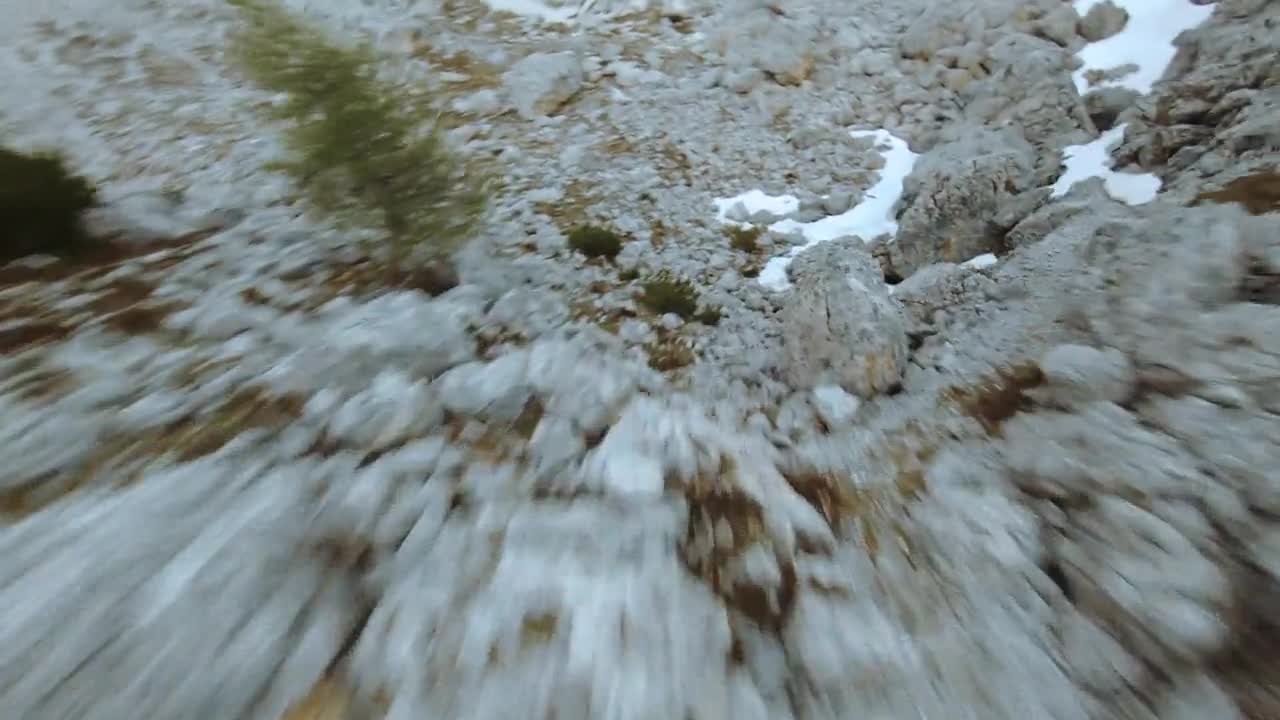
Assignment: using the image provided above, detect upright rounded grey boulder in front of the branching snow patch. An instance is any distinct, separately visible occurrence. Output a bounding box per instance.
[782,238,908,397]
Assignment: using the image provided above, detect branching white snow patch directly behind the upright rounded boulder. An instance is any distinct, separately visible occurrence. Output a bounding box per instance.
[716,129,919,291]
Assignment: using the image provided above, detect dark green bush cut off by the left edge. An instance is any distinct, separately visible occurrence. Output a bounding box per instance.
[0,147,97,261]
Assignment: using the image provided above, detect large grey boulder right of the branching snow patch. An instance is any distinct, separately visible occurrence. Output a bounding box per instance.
[887,128,1036,277]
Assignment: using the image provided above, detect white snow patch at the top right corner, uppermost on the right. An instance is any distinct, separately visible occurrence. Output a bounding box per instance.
[1071,0,1213,95]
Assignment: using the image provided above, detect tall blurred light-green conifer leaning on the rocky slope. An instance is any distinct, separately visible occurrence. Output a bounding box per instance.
[228,0,486,260]
